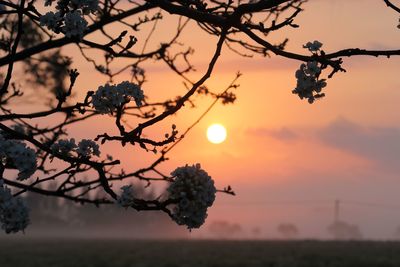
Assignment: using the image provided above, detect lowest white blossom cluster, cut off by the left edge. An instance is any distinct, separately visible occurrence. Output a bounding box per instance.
[0,182,29,234]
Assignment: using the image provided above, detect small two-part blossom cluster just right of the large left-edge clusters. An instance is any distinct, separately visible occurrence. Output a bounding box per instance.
[51,138,100,158]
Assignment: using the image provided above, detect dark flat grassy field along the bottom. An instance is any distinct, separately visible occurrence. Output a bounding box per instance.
[0,239,400,267]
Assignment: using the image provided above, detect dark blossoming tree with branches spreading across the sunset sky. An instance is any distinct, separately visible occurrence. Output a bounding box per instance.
[0,0,400,233]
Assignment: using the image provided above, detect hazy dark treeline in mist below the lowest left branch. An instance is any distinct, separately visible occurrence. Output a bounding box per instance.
[26,184,188,238]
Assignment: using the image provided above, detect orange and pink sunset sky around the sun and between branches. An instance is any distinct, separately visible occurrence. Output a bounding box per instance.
[7,0,400,239]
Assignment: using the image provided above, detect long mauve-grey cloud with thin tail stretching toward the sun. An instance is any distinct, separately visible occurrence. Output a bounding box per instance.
[246,117,400,172]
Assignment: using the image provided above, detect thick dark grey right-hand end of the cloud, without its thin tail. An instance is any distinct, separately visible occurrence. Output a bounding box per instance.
[316,117,400,170]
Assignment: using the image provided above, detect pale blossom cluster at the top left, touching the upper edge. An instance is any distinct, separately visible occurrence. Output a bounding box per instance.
[40,0,99,38]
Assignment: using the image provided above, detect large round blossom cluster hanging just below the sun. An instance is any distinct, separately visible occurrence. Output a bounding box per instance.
[167,164,217,229]
